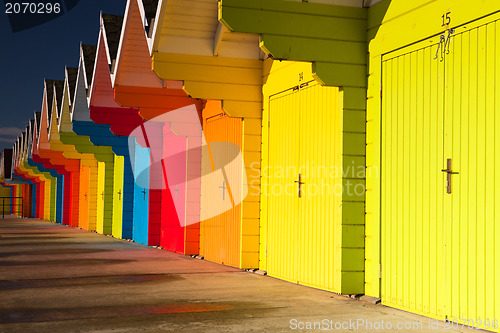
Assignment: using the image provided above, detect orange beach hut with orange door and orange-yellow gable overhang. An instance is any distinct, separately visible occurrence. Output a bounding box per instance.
[147,0,265,268]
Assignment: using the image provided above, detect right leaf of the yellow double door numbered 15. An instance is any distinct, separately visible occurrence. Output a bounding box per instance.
[442,15,500,331]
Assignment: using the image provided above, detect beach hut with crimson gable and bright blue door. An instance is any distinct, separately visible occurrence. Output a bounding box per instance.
[87,14,153,245]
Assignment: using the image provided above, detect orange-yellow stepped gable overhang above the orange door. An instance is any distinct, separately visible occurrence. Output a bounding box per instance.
[151,0,265,119]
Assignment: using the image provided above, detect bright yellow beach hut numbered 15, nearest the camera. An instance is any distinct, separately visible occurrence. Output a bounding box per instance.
[366,0,500,330]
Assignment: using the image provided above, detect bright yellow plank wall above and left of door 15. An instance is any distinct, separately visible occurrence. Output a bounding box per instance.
[365,0,498,297]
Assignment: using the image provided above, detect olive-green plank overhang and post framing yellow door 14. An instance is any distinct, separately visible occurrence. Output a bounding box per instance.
[219,0,368,293]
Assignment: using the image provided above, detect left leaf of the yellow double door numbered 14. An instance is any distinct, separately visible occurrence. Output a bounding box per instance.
[263,85,300,282]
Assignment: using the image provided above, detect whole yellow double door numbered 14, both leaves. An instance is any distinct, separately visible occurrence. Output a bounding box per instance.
[270,81,342,291]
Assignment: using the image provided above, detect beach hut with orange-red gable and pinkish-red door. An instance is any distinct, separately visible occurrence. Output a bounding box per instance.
[111,1,203,250]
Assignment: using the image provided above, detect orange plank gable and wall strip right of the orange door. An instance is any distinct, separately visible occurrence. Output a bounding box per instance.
[151,0,263,268]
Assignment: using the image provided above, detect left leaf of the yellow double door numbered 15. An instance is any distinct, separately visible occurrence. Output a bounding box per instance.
[381,40,445,316]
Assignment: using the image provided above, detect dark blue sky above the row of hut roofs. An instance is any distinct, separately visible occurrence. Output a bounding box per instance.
[0,0,126,150]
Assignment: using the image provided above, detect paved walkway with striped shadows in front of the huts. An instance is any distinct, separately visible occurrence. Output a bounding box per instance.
[0,217,476,333]
